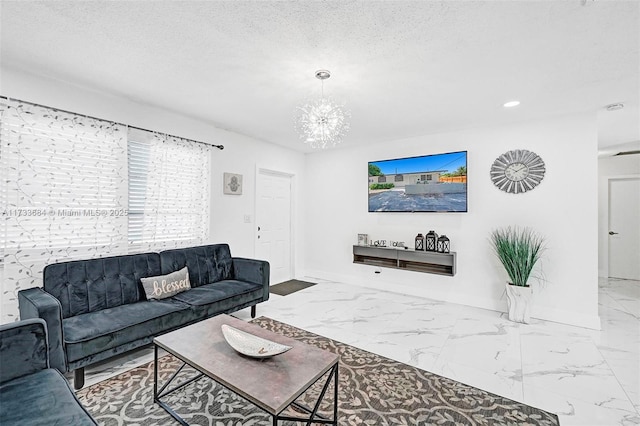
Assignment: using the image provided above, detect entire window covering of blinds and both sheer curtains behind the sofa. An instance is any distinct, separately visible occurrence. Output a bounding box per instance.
[0,99,212,323]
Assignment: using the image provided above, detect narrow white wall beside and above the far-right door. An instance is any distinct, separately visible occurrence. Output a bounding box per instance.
[598,154,640,277]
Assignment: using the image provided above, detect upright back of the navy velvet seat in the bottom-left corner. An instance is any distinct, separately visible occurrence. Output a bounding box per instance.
[0,318,49,383]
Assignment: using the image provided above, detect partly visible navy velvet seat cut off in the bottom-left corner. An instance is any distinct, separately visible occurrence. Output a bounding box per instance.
[0,319,97,426]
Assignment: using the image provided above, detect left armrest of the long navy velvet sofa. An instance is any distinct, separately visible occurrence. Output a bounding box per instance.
[18,287,67,373]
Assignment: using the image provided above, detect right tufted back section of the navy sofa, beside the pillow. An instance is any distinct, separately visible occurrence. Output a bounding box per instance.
[160,244,233,287]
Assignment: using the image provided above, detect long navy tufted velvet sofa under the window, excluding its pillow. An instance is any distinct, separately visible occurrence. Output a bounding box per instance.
[18,244,269,389]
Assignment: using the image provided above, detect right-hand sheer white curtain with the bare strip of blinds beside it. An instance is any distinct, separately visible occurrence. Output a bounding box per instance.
[129,128,212,252]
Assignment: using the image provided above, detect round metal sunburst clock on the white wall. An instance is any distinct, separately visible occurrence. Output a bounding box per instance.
[490,149,545,194]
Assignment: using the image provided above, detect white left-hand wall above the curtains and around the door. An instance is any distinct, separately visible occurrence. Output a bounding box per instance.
[0,68,305,320]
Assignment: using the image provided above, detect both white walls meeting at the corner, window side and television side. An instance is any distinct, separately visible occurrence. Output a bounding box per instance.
[0,69,599,328]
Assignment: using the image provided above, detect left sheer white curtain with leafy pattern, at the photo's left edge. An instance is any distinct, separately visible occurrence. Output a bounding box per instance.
[0,99,128,323]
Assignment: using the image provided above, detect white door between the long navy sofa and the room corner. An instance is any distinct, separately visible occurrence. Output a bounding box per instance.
[256,170,293,284]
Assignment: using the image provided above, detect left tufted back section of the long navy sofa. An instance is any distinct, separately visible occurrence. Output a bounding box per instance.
[43,253,161,318]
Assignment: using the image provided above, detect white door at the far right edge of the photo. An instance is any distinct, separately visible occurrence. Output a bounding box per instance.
[609,178,640,280]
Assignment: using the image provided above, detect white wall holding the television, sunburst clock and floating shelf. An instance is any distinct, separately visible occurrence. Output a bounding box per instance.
[305,114,600,328]
